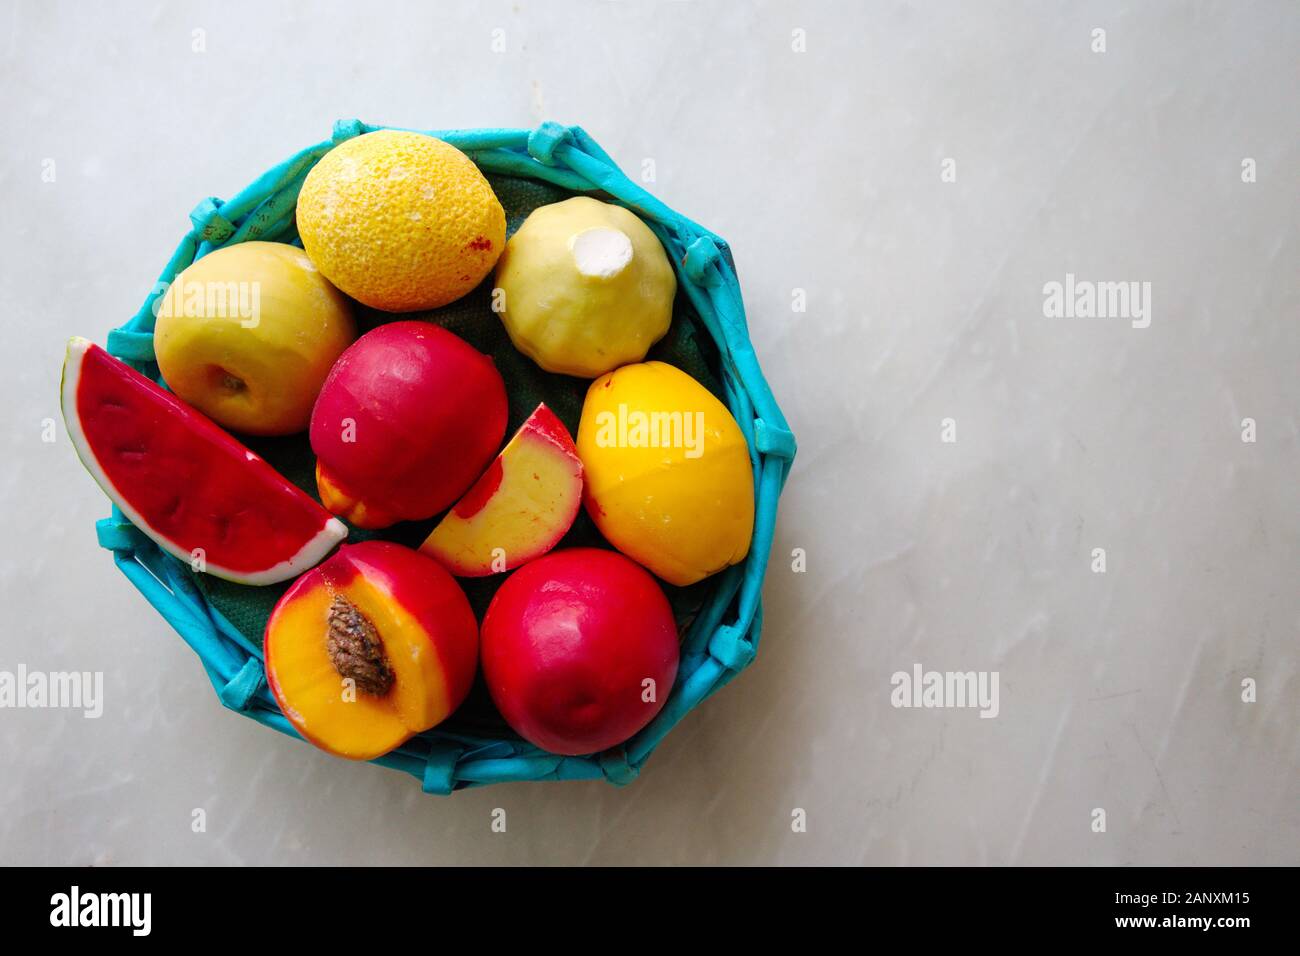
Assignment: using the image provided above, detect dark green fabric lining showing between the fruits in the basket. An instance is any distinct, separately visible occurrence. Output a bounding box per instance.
[190,173,727,734]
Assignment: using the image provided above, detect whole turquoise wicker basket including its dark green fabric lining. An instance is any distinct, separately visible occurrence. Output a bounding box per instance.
[98,120,794,793]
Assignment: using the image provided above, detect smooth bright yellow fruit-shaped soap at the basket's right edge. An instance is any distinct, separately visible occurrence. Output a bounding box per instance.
[577,362,754,585]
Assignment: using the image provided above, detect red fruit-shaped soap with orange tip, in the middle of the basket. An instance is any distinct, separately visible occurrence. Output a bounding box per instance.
[311,321,507,528]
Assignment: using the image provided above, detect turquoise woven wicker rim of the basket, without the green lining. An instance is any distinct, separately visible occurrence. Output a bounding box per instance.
[98,120,794,793]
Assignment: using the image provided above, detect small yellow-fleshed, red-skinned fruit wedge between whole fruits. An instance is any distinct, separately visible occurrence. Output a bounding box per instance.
[420,405,582,578]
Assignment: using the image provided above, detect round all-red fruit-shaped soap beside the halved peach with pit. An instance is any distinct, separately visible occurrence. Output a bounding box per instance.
[482,548,679,754]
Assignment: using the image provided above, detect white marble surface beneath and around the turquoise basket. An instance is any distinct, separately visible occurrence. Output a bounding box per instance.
[0,0,1300,864]
